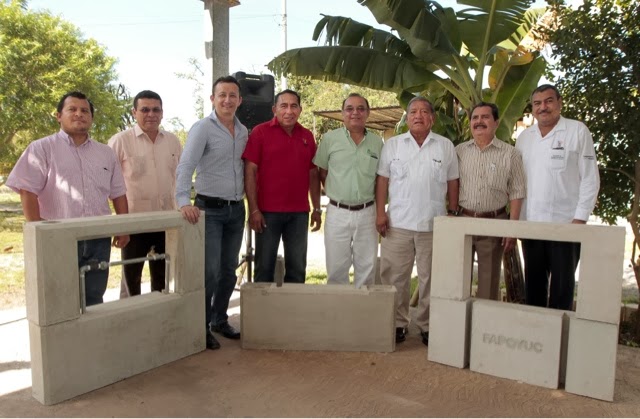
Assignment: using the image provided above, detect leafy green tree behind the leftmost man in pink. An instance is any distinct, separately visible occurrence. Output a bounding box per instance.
[0,1,130,174]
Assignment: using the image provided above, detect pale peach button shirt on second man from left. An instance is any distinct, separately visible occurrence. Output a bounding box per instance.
[109,125,182,213]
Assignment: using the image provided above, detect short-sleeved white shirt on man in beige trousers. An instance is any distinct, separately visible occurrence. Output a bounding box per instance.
[378,132,459,232]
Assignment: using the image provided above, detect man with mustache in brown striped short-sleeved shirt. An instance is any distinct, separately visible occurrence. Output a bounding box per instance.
[456,102,526,300]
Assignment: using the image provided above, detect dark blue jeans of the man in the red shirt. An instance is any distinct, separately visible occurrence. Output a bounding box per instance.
[255,212,309,283]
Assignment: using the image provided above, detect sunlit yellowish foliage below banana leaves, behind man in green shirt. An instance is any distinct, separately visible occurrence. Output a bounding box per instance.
[288,76,398,140]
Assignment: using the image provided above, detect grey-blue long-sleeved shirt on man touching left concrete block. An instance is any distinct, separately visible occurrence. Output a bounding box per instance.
[176,111,248,208]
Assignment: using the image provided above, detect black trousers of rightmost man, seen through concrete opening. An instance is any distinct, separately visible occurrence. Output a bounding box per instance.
[522,240,580,310]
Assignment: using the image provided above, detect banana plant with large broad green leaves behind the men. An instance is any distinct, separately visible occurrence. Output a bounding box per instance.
[268,0,545,140]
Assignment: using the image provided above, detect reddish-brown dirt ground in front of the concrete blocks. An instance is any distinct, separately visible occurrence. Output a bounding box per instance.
[0,308,640,417]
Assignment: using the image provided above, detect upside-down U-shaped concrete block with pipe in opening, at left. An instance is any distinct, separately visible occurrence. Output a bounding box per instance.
[24,211,204,326]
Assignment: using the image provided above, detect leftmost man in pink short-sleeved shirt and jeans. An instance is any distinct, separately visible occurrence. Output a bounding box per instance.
[6,92,129,306]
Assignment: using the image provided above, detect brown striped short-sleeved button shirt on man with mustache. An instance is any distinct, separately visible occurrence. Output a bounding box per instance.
[456,137,526,212]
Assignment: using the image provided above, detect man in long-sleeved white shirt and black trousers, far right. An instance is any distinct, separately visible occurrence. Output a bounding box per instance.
[516,84,600,310]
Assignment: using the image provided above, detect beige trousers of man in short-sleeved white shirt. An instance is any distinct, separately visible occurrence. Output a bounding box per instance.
[380,228,433,332]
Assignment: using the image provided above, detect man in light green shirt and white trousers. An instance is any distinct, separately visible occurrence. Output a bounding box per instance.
[313,93,382,288]
